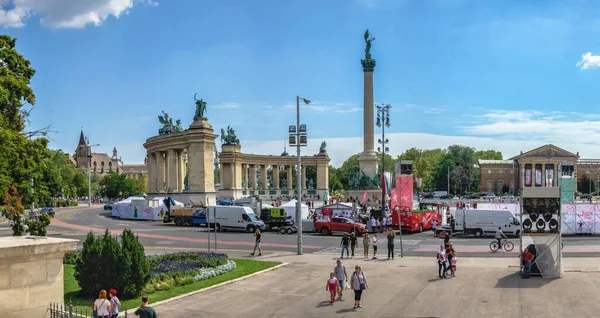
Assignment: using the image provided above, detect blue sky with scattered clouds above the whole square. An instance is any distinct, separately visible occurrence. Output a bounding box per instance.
[5,0,600,165]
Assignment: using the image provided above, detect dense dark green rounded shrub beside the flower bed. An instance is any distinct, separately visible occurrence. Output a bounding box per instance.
[74,229,150,298]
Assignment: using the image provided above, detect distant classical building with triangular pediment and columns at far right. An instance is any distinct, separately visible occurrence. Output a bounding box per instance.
[479,144,600,193]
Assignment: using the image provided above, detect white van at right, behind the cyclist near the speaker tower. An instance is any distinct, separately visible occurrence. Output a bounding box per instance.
[454,209,521,237]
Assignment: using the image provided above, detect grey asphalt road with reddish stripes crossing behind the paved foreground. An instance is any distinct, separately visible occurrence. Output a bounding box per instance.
[0,207,600,258]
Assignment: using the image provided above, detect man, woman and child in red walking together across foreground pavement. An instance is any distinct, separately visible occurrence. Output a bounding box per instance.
[325,260,369,309]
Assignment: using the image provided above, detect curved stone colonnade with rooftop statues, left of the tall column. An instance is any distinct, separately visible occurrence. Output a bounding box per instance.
[144,108,329,205]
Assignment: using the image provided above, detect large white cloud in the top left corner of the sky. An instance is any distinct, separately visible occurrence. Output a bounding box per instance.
[0,0,158,28]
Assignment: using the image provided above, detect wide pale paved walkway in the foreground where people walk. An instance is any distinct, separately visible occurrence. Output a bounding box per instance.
[150,253,600,318]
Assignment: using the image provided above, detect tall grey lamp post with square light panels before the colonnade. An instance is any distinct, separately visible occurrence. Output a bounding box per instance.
[288,96,310,255]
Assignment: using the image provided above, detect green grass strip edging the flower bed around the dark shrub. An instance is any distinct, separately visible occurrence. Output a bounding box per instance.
[64,259,280,311]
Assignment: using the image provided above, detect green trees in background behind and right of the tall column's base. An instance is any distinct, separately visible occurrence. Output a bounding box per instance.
[328,145,502,194]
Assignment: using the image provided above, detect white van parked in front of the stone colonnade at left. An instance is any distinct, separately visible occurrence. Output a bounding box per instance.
[207,205,265,233]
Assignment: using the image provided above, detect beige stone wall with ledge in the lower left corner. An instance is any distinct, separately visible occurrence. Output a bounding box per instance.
[0,237,77,318]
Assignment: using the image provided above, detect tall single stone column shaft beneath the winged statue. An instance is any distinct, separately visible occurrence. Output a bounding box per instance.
[359,53,377,177]
